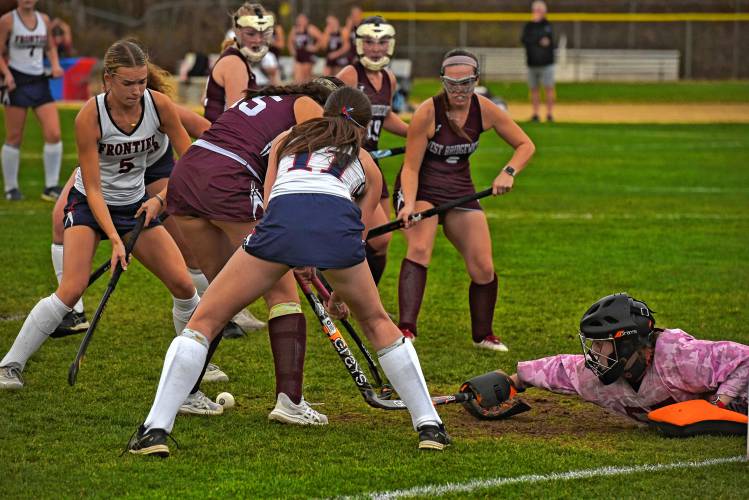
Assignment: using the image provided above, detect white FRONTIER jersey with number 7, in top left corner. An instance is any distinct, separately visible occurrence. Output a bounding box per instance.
[8,10,47,76]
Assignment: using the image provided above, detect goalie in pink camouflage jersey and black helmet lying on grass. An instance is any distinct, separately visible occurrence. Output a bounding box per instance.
[470,293,749,435]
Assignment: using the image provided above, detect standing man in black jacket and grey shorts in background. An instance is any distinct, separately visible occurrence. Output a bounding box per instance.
[521,0,555,122]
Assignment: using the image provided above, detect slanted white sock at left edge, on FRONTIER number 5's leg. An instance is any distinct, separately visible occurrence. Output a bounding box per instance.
[0,293,70,370]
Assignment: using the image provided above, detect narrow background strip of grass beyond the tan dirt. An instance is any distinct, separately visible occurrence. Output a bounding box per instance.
[410,78,749,103]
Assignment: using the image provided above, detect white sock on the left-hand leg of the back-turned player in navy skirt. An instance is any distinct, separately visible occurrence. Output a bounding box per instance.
[143,328,208,432]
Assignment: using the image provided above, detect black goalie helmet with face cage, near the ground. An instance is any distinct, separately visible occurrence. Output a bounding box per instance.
[580,293,655,387]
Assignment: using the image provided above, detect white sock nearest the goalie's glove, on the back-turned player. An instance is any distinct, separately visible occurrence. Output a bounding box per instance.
[377,338,442,429]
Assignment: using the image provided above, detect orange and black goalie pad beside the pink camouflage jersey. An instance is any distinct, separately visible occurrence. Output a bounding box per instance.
[648,399,747,437]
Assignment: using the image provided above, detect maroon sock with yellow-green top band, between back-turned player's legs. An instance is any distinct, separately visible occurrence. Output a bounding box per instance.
[268,313,307,404]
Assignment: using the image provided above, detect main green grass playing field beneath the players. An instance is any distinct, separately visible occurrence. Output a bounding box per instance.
[0,104,749,498]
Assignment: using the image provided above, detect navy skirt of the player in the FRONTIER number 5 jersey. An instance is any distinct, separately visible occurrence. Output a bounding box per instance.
[62,187,161,240]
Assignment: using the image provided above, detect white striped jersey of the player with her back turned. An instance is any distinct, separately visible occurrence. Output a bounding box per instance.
[268,148,366,201]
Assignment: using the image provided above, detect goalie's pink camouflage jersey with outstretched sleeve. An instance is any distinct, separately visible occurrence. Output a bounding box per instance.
[517,329,749,422]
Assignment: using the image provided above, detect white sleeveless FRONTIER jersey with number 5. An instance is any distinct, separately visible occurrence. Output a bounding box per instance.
[75,89,164,205]
